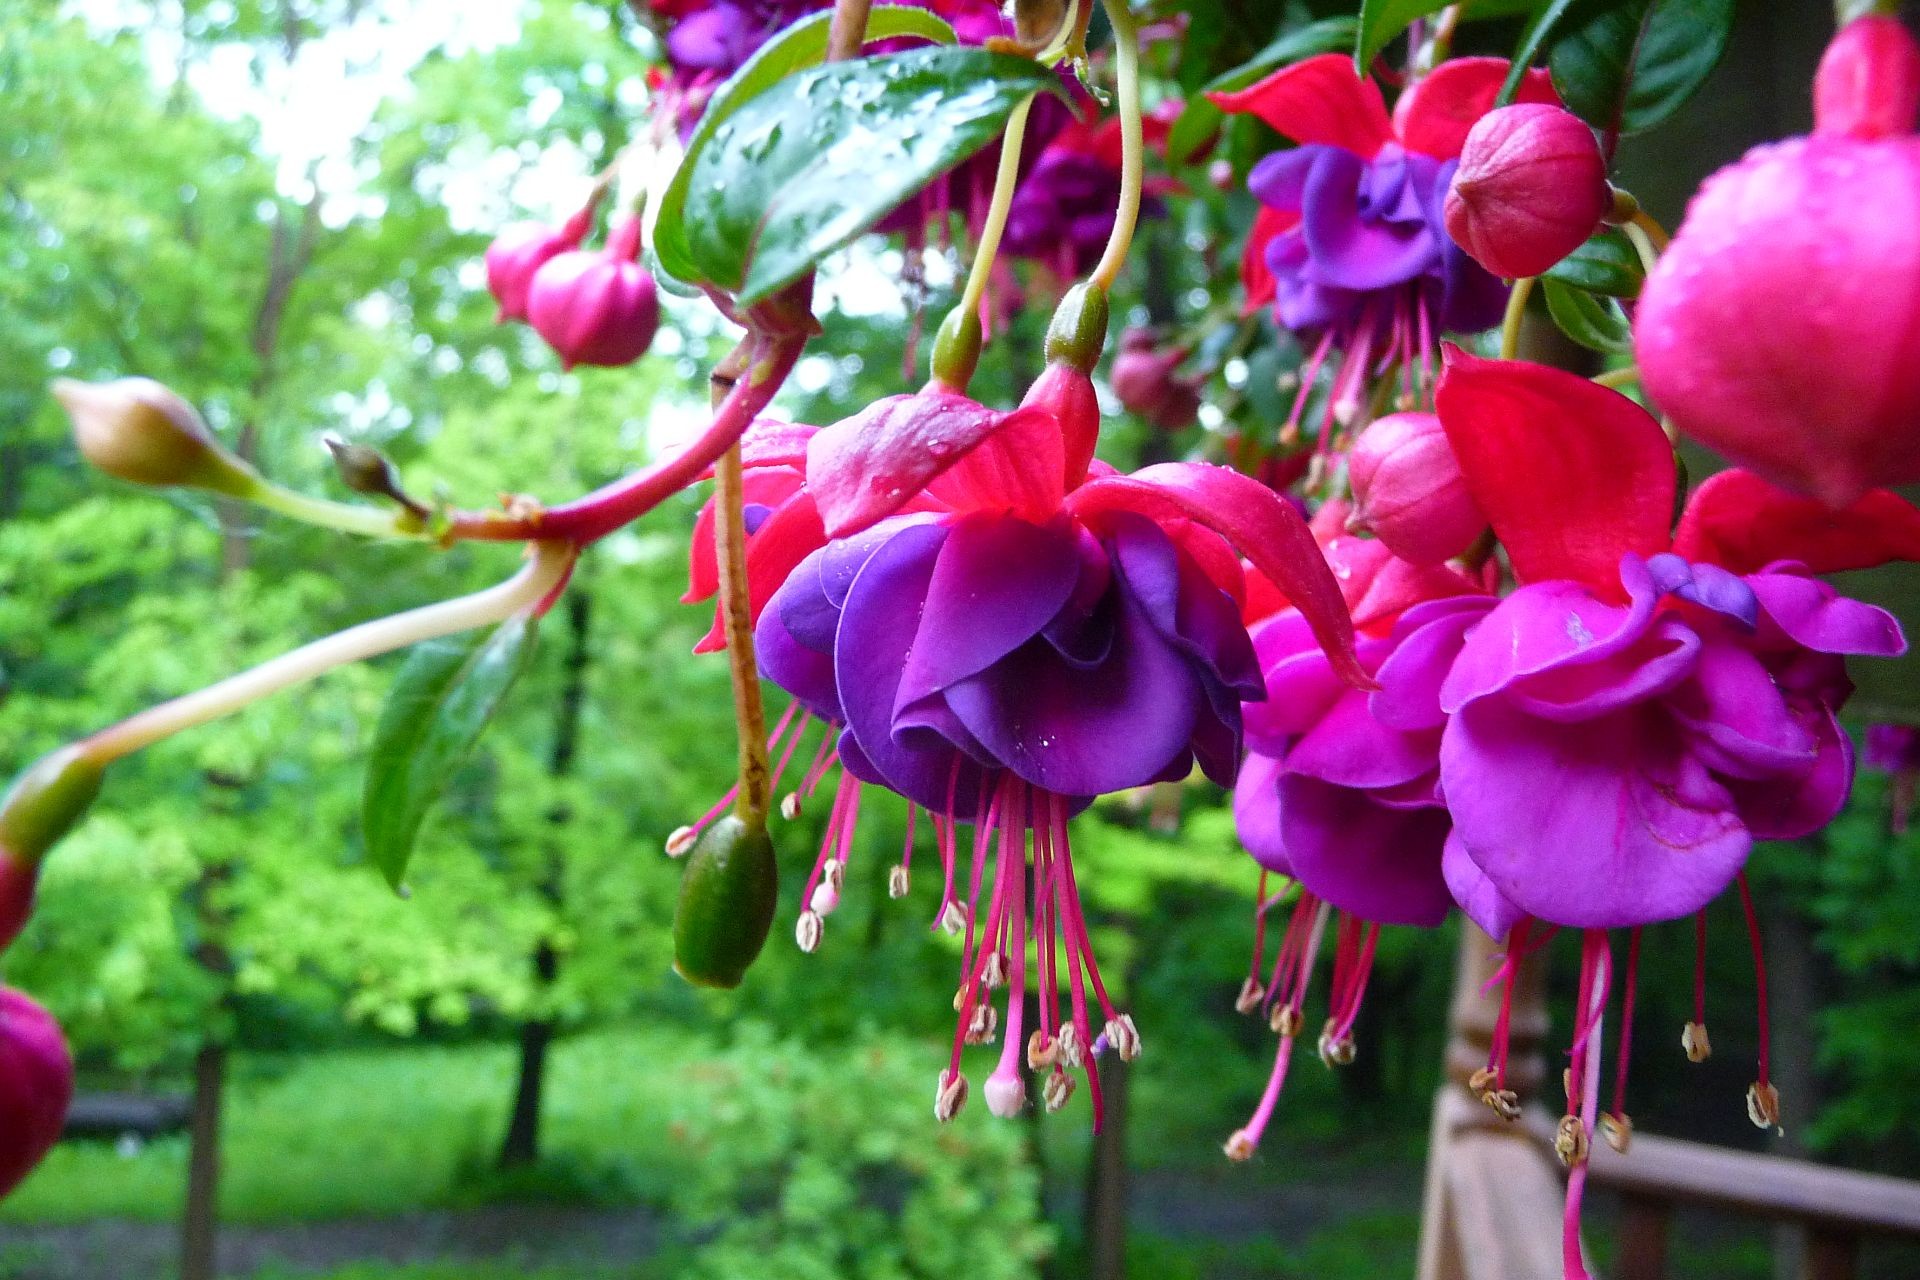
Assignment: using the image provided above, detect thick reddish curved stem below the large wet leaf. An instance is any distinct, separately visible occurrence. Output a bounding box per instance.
[445,334,806,545]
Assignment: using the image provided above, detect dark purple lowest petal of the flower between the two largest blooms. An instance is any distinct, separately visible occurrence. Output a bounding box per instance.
[1279,773,1453,927]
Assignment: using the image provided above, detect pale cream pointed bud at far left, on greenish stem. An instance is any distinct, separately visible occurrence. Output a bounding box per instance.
[52,378,259,497]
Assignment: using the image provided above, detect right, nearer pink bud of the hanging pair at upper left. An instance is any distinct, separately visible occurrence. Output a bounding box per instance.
[526,219,660,368]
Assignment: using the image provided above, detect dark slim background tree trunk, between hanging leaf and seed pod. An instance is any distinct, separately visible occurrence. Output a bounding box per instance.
[499,587,593,1169]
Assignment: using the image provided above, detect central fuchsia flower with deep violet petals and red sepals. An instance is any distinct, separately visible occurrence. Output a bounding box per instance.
[756,364,1365,1123]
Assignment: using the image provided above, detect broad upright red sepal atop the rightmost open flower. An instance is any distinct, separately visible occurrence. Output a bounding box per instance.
[1434,344,1674,599]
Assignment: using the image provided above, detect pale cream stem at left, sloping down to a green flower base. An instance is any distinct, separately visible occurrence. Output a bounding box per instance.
[77,541,576,764]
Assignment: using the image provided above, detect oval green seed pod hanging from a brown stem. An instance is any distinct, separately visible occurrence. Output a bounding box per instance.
[674,814,780,986]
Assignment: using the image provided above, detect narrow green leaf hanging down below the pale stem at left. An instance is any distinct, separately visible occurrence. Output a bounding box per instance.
[361,618,534,889]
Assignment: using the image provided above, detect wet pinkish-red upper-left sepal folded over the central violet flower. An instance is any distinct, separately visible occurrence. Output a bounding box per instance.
[806,391,1060,537]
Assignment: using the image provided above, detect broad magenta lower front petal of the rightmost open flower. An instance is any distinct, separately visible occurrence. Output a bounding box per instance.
[1440,699,1751,929]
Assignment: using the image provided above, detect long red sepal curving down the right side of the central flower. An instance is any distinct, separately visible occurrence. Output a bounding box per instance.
[1068,462,1373,689]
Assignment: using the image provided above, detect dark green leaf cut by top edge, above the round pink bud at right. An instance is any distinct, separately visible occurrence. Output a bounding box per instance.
[1548,0,1734,132]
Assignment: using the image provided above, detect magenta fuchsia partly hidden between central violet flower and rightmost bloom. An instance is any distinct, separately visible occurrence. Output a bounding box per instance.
[1227,505,1494,1159]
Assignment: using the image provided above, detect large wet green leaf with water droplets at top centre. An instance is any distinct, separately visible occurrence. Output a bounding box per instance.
[680,46,1062,305]
